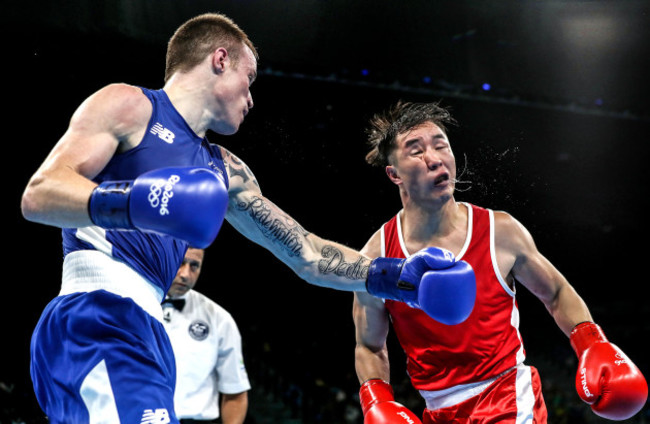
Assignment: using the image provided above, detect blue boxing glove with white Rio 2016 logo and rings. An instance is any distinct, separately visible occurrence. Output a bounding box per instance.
[88,167,228,248]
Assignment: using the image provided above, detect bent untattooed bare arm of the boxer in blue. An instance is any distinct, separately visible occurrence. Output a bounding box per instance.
[21,84,151,228]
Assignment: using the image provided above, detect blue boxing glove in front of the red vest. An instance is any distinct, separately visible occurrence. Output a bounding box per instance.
[366,247,476,325]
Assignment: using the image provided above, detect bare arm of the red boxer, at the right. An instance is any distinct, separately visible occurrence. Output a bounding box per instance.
[495,212,592,337]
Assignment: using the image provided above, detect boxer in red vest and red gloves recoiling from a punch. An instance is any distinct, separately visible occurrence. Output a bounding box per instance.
[354,103,648,424]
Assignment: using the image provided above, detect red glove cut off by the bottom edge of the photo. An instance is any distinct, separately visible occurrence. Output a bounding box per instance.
[359,378,422,424]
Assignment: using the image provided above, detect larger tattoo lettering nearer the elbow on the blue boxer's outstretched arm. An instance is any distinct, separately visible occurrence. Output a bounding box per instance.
[237,197,309,256]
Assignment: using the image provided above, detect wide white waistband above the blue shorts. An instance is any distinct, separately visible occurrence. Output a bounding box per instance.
[59,250,164,322]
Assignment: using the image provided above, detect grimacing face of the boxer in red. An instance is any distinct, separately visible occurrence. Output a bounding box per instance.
[386,122,456,201]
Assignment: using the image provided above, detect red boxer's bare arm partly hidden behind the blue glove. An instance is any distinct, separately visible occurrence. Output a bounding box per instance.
[352,232,390,384]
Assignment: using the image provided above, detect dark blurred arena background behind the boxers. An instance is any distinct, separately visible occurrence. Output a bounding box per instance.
[0,0,650,424]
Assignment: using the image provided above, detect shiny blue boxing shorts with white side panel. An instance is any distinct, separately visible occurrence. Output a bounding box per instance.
[31,290,178,424]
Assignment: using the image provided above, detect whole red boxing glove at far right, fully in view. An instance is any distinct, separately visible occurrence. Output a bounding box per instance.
[570,322,648,421]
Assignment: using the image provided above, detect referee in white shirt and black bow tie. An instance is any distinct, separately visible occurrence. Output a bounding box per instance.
[163,248,251,424]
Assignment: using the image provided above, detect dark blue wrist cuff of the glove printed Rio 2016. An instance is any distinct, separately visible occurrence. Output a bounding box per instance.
[88,181,135,230]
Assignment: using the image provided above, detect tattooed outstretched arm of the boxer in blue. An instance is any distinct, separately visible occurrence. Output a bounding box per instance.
[222,148,370,291]
